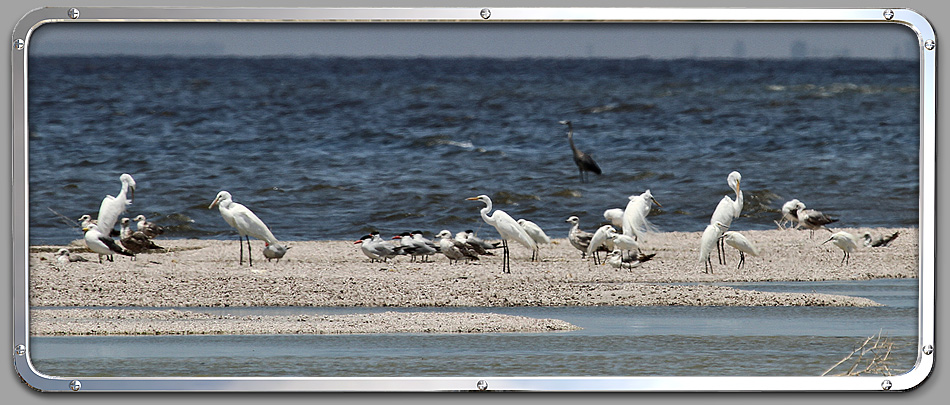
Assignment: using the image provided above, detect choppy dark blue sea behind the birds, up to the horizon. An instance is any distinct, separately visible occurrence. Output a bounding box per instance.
[28,57,919,244]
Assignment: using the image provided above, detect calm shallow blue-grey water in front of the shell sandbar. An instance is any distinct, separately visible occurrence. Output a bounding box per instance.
[30,279,918,377]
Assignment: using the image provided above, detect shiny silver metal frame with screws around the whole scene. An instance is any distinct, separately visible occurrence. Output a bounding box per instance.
[10,7,937,392]
